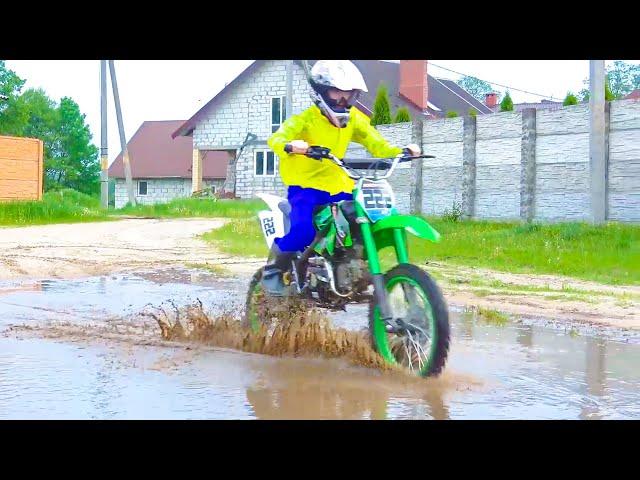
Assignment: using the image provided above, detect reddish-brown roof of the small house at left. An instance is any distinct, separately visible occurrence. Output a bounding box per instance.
[109,120,229,179]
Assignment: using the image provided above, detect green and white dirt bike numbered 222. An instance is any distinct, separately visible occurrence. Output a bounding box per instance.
[245,146,449,377]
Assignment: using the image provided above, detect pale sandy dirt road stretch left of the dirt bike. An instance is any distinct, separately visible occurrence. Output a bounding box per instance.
[0,219,258,279]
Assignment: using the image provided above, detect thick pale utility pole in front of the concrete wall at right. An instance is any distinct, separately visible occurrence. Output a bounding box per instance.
[589,60,606,224]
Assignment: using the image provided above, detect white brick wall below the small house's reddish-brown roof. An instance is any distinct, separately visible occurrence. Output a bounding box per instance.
[115,178,224,208]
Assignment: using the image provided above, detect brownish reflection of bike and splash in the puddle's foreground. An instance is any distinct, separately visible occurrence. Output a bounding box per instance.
[246,360,449,420]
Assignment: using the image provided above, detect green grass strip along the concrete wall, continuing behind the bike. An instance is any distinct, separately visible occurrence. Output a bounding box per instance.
[206,218,640,286]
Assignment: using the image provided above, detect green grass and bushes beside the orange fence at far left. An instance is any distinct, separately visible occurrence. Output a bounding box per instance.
[0,189,109,226]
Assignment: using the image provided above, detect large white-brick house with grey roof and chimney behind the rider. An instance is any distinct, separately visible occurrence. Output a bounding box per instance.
[172,60,492,198]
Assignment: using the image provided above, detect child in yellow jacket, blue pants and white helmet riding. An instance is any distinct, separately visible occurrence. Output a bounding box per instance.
[262,60,420,296]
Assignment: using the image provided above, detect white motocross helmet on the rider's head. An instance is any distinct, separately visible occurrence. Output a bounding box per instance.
[309,60,368,128]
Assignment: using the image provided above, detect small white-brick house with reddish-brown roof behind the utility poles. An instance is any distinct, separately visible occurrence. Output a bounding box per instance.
[108,120,229,208]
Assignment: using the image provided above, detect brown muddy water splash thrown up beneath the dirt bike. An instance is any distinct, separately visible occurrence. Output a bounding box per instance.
[143,299,400,371]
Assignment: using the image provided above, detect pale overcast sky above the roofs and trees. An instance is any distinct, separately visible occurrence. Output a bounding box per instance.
[6,60,640,167]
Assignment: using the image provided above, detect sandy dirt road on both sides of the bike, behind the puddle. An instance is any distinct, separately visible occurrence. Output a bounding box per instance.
[0,219,640,329]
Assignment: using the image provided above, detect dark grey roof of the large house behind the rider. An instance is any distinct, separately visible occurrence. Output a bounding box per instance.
[172,60,492,138]
